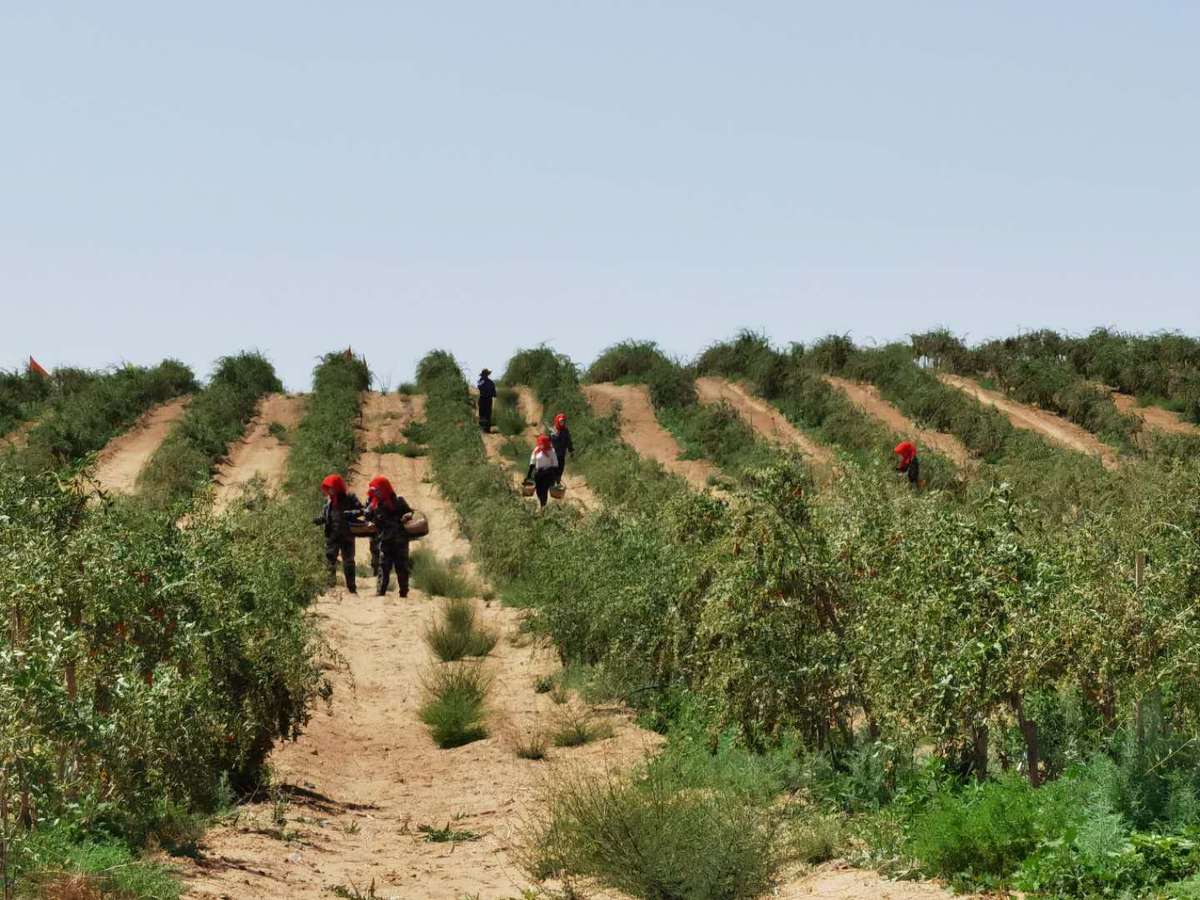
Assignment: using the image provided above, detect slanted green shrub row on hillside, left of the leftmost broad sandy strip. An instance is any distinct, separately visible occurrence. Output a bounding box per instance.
[18,360,197,472]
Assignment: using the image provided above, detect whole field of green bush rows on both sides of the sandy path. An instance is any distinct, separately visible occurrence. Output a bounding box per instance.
[0,331,1200,898]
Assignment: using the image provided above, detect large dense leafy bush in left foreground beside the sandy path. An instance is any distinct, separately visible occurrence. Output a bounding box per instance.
[0,470,324,844]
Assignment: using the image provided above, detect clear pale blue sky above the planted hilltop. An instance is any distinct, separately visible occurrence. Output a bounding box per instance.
[0,0,1200,388]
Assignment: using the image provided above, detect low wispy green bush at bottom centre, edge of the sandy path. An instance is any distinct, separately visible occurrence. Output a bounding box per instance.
[520,764,781,900]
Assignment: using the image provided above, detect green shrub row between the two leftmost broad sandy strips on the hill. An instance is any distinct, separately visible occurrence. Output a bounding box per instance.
[138,353,283,504]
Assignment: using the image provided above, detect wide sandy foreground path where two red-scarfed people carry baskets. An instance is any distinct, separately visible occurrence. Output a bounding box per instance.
[186,395,660,900]
